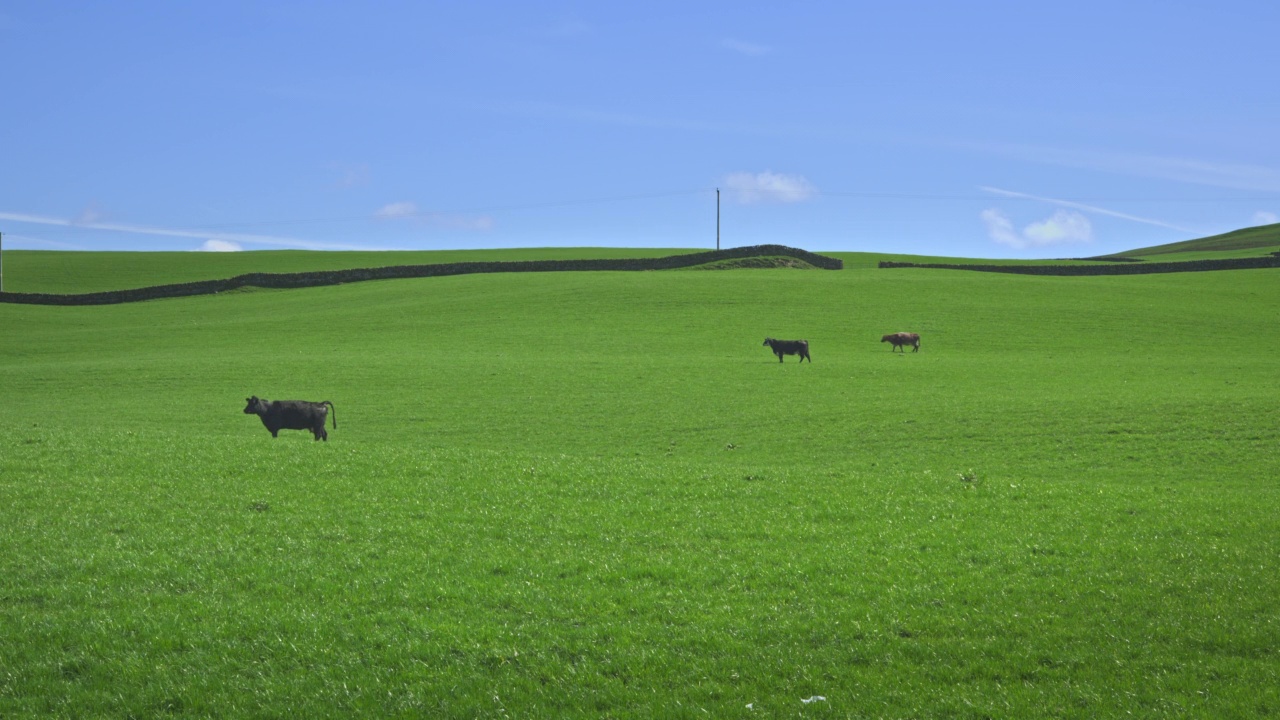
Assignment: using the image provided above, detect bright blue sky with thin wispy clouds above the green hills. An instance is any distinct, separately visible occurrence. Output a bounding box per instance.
[0,0,1280,258]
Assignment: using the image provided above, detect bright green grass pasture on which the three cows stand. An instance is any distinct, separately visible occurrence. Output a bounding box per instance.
[0,243,1280,717]
